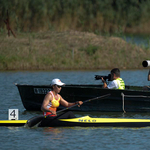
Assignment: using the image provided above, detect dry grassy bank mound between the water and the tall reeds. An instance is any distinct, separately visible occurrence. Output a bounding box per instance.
[0,31,150,70]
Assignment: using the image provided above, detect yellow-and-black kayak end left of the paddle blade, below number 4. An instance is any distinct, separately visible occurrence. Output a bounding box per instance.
[0,120,27,127]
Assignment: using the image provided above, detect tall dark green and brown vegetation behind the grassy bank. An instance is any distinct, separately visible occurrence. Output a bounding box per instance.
[0,0,150,33]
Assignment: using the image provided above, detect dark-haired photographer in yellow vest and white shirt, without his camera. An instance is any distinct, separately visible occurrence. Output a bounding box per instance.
[102,68,125,90]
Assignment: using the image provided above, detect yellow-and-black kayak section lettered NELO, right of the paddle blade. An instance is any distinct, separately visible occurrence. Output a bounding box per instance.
[37,116,150,127]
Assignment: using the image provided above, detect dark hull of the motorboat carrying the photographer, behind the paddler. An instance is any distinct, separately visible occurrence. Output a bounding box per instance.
[16,84,150,112]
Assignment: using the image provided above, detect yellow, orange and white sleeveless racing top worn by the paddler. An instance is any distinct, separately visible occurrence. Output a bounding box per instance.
[43,91,60,117]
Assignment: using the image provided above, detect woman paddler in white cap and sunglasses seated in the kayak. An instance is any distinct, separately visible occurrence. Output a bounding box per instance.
[39,79,83,127]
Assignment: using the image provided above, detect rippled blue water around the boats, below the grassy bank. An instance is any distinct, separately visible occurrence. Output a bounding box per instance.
[0,69,150,150]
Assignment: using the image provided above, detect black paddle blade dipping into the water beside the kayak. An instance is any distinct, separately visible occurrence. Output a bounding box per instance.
[27,116,44,127]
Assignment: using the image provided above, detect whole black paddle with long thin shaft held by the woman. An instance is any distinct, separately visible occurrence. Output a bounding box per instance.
[27,94,111,127]
